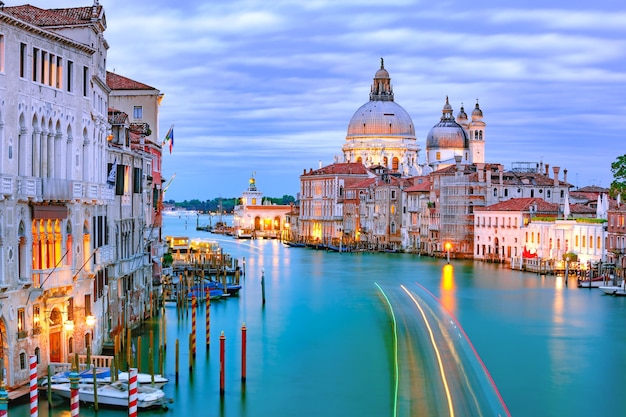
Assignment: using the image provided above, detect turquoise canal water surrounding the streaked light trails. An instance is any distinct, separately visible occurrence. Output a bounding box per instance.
[9,213,626,417]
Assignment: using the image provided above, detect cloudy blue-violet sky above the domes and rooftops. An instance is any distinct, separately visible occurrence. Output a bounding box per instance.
[44,0,626,201]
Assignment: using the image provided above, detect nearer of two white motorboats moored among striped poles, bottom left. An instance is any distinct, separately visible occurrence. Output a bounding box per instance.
[50,381,168,408]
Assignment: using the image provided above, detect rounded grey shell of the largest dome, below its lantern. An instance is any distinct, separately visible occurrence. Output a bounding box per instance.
[346,101,415,139]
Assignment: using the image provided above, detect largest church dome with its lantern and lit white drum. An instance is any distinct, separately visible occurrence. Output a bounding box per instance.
[342,58,421,176]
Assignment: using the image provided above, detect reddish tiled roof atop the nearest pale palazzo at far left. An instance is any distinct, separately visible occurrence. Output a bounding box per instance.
[3,4,102,27]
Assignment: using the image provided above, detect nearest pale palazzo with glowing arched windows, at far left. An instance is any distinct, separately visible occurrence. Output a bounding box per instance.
[0,2,113,388]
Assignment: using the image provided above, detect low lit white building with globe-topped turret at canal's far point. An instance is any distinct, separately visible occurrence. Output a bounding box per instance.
[233,175,292,239]
